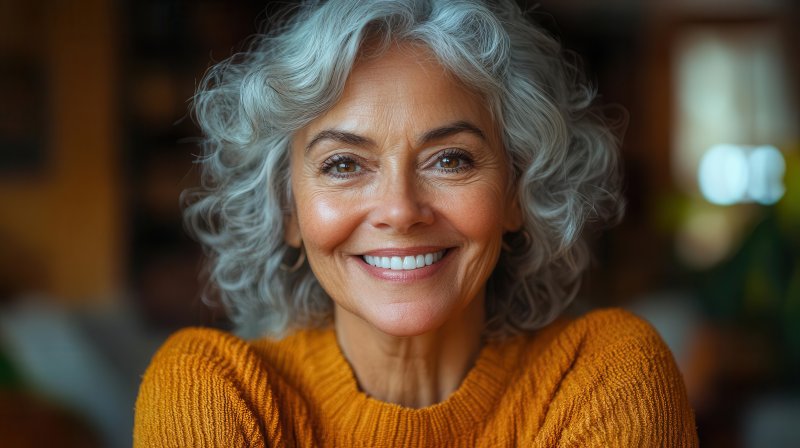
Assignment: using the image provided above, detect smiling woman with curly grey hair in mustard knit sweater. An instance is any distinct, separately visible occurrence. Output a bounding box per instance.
[134,0,696,446]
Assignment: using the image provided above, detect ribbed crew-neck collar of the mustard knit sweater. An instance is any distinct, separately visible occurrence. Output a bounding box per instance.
[304,331,519,446]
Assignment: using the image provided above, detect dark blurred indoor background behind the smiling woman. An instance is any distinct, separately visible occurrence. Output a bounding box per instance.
[0,0,800,447]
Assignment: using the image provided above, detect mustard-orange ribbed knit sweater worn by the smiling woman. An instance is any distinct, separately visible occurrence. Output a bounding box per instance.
[133,310,697,447]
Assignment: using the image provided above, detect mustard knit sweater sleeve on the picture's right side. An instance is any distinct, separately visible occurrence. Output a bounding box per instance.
[546,310,698,447]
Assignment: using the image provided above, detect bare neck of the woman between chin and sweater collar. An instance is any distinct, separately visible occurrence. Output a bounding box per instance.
[336,299,484,408]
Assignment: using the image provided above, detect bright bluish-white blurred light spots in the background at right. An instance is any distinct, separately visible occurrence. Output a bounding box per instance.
[698,145,786,205]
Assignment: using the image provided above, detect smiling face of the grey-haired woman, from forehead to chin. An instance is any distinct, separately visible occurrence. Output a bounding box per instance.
[287,45,520,336]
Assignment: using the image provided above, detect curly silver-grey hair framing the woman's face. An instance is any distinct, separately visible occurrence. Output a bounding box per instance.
[183,0,623,337]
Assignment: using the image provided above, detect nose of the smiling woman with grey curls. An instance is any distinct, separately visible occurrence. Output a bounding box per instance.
[370,165,434,234]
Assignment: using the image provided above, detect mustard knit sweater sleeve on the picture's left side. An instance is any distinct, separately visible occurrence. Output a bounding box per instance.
[133,329,280,447]
